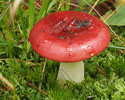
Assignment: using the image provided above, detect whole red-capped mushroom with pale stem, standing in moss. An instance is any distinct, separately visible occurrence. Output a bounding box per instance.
[29,11,110,83]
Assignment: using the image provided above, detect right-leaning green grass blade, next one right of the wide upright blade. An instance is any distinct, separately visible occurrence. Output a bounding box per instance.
[37,0,50,21]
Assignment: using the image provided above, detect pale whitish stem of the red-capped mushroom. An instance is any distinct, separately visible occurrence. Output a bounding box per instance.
[57,61,84,83]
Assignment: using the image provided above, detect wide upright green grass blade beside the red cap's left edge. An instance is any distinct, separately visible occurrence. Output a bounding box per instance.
[29,0,35,31]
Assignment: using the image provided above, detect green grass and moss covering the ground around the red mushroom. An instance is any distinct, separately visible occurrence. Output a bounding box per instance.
[0,0,125,100]
